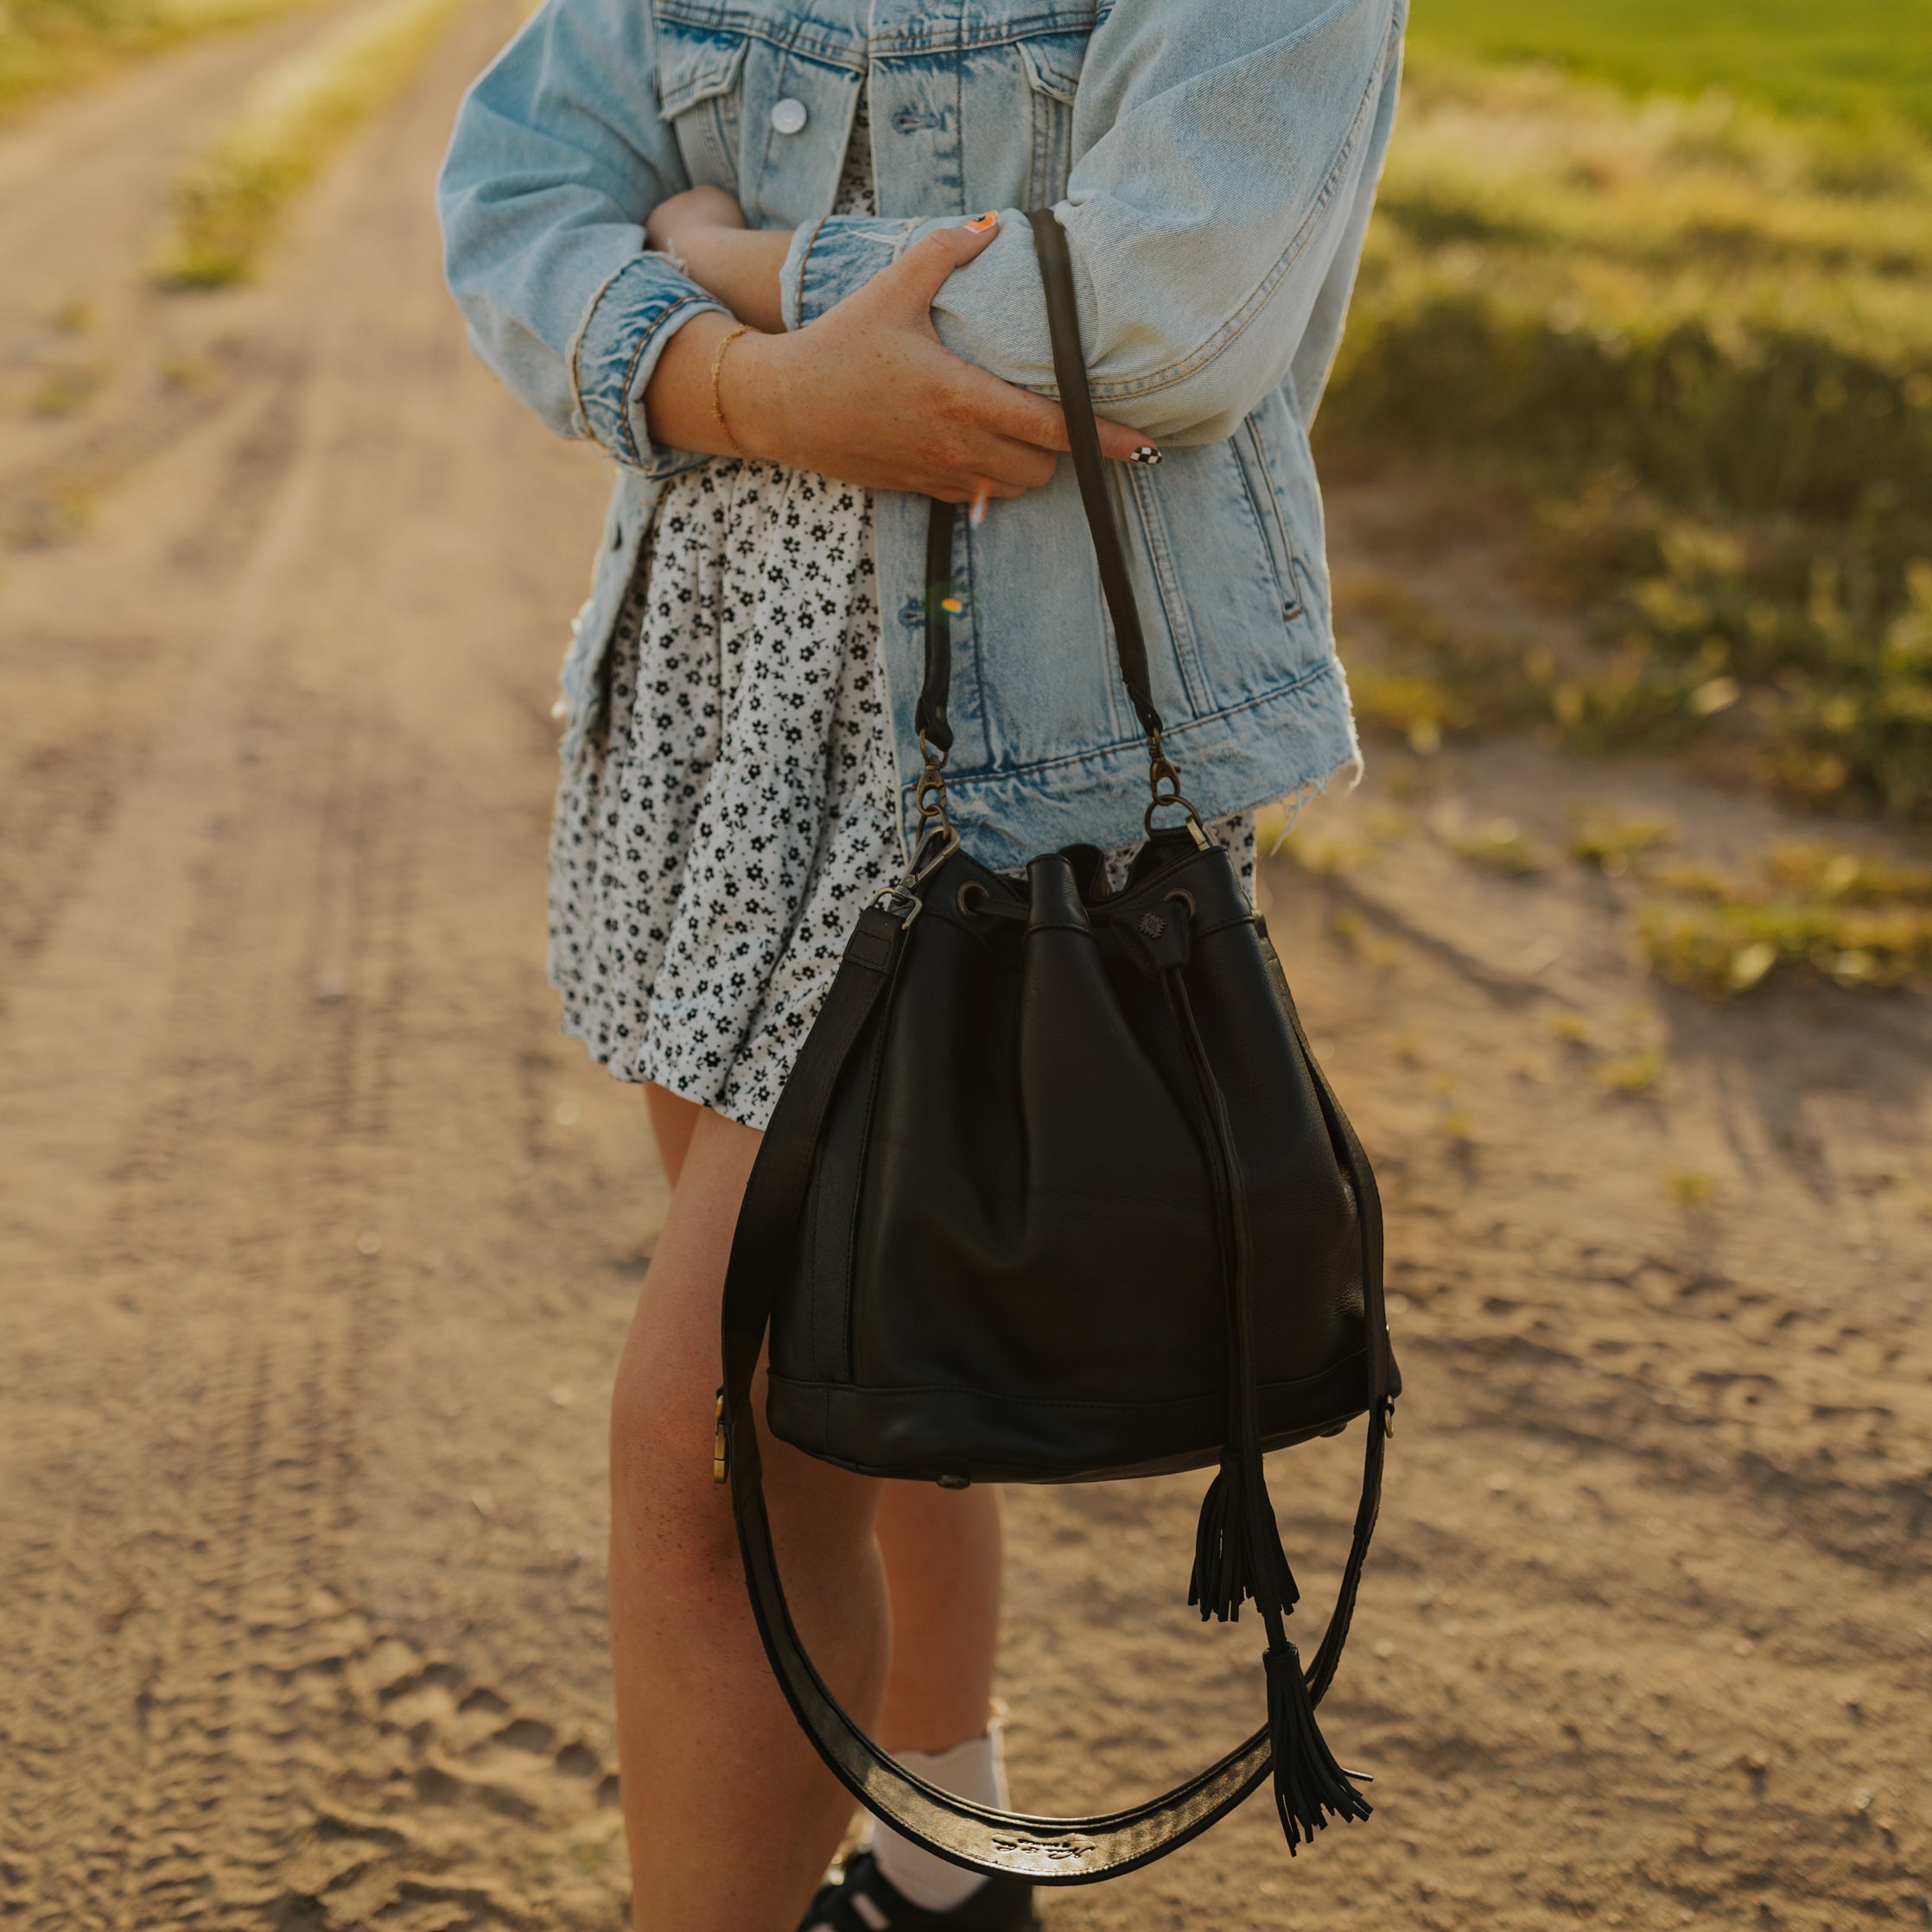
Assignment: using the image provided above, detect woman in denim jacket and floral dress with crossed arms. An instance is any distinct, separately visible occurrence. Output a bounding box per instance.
[441,0,1405,1932]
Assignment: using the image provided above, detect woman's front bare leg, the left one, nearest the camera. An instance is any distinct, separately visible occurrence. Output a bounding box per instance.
[611,1113,893,1932]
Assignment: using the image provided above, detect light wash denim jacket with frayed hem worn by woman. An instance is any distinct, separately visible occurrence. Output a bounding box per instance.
[439,0,1407,866]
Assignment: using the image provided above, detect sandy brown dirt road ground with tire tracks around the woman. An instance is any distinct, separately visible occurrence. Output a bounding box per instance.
[0,6,1932,1932]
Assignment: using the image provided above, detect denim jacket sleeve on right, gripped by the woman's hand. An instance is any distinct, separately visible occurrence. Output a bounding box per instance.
[780,0,1407,442]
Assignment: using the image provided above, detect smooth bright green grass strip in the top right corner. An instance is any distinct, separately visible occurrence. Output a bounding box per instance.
[1410,0,1932,130]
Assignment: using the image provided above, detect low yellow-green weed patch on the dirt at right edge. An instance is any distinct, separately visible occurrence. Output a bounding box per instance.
[1636,842,1932,999]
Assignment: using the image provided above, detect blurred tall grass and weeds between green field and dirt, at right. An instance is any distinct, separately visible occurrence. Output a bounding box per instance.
[1319,66,1932,817]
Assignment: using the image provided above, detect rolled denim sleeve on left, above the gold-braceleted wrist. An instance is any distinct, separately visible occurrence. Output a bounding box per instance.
[436,0,722,477]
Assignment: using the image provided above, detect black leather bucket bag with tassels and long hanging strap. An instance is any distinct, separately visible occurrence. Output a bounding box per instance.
[717,214,1401,1884]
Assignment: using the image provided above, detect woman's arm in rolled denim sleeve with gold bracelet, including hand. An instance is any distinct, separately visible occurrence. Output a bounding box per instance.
[439,0,1146,490]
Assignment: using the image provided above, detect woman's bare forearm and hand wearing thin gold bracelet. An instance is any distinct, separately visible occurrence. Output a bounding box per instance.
[645,215,1157,502]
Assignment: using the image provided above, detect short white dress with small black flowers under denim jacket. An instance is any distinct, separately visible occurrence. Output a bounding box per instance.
[550,108,1254,1128]
